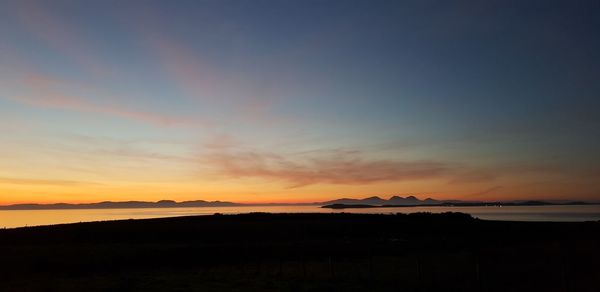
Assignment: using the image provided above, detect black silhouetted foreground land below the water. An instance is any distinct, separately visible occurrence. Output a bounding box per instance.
[0,214,600,292]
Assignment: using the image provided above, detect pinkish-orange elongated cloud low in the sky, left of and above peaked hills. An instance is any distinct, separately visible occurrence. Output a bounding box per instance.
[202,147,448,187]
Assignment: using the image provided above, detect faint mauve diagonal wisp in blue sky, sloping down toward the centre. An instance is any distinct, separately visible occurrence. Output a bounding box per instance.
[124,7,291,125]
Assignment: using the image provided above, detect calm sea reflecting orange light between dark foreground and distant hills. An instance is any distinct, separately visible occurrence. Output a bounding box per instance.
[0,205,600,228]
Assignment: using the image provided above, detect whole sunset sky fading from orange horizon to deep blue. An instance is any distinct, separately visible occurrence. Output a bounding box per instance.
[0,0,600,204]
